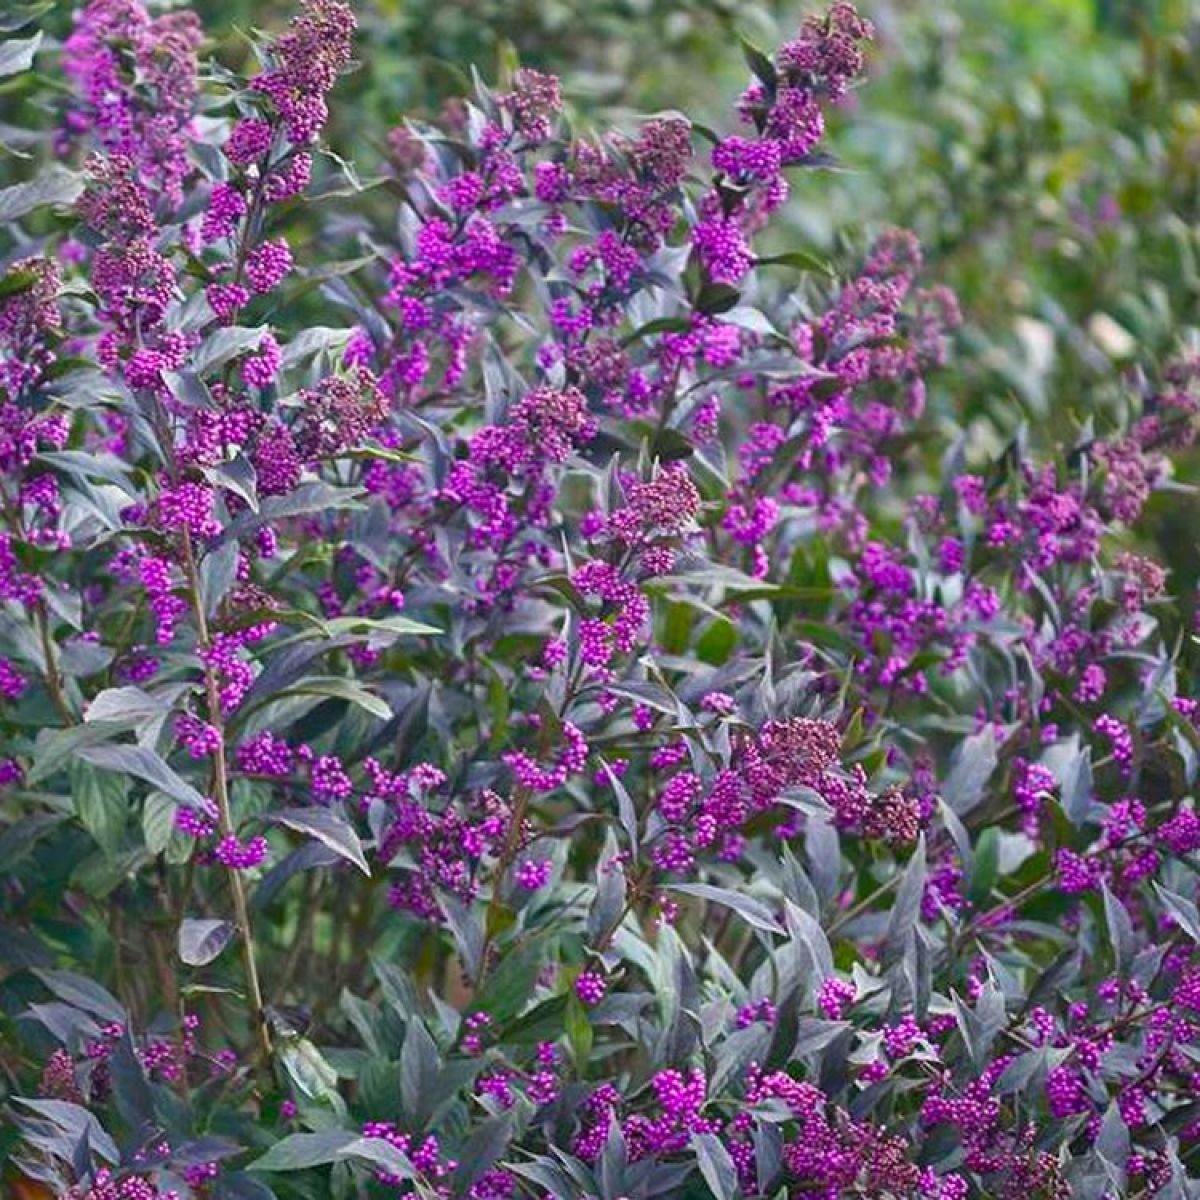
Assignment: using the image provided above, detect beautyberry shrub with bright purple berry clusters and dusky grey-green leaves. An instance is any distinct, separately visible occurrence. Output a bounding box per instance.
[0,0,1200,1200]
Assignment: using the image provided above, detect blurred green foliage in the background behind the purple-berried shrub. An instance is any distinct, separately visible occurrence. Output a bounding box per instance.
[7,0,1200,589]
